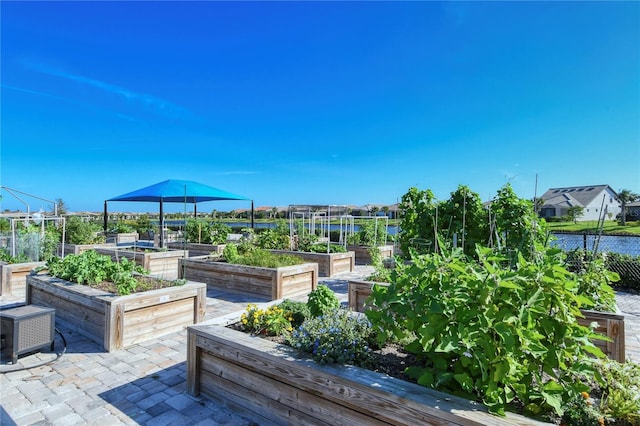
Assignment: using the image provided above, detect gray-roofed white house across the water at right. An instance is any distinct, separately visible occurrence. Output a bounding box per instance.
[539,185,620,221]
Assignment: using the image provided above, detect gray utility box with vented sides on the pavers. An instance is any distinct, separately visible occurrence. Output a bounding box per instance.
[0,305,56,364]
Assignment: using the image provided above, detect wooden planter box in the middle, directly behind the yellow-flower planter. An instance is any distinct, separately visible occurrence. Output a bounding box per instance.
[180,258,318,300]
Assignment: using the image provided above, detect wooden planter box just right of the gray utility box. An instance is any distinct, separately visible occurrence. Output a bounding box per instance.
[27,275,207,352]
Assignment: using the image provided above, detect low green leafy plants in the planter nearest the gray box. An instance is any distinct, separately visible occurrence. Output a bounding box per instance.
[47,250,147,295]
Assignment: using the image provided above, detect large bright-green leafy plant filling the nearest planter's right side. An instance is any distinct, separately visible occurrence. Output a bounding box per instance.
[367,247,604,414]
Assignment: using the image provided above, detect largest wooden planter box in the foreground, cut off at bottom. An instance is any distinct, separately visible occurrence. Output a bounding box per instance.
[187,325,544,426]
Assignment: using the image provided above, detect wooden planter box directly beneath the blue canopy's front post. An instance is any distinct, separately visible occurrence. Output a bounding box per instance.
[95,247,189,280]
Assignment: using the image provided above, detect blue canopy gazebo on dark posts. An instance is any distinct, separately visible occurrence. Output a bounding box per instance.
[104,179,254,247]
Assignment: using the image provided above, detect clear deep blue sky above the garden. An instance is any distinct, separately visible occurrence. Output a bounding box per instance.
[0,1,640,211]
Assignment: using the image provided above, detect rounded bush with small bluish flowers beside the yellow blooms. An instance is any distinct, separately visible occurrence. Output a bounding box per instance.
[289,309,373,367]
